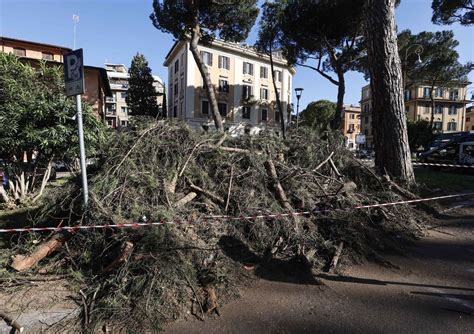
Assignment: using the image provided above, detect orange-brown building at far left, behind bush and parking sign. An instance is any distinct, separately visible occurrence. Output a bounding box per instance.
[0,36,111,120]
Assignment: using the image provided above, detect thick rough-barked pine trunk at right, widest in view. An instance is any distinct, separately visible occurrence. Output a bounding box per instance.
[365,0,415,184]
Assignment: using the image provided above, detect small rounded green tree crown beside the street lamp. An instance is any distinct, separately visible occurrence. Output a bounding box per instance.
[300,100,336,130]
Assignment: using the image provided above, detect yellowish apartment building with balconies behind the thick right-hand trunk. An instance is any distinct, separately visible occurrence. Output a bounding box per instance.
[360,82,470,148]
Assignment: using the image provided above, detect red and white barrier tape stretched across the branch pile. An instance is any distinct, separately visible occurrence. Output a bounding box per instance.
[0,193,474,233]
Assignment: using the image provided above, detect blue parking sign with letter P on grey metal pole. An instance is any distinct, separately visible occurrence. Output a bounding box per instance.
[64,49,89,207]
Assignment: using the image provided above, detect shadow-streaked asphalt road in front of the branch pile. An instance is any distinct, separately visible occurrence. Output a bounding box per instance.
[165,207,474,333]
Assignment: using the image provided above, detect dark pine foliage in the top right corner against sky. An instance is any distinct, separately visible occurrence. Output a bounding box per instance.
[431,0,474,25]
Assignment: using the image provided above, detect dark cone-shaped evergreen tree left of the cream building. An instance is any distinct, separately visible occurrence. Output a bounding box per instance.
[126,53,159,118]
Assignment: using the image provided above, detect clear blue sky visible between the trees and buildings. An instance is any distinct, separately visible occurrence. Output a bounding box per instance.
[0,0,474,110]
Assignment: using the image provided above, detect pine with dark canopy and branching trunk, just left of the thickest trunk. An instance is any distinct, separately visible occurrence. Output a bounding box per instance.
[267,0,363,129]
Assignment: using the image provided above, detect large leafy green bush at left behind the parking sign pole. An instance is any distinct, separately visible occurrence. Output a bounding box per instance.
[0,52,105,159]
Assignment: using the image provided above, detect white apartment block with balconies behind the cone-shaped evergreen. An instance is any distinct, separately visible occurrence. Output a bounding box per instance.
[105,63,164,128]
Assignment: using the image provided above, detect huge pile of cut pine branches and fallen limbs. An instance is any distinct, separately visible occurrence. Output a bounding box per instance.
[3,121,426,331]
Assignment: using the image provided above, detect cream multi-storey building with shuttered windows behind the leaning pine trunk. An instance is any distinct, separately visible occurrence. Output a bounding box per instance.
[164,40,295,135]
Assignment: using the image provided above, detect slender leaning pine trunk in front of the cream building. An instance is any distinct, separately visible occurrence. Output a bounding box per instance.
[189,24,224,133]
